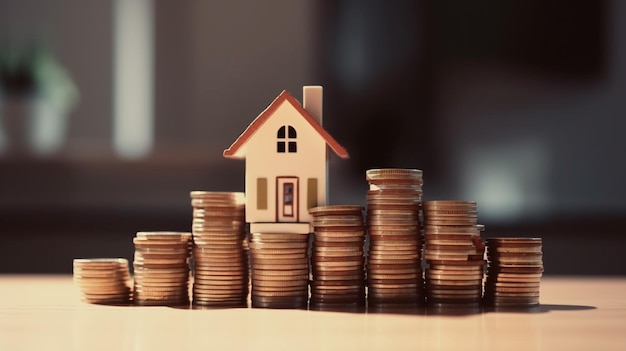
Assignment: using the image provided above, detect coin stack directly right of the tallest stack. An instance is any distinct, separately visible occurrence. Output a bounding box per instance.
[423,201,485,306]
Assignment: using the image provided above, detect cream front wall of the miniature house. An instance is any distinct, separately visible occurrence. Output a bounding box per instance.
[244,100,327,223]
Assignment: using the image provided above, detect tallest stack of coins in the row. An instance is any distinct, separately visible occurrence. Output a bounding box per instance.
[366,169,424,304]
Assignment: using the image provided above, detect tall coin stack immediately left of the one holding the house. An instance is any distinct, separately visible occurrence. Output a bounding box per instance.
[191,191,249,306]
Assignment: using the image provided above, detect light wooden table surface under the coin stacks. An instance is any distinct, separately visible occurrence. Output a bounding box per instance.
[0,275,626,351]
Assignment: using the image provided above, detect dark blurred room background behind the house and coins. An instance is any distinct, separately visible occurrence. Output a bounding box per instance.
[0,0,626,275]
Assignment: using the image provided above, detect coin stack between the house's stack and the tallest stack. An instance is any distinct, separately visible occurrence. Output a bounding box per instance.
[309,205,365,305]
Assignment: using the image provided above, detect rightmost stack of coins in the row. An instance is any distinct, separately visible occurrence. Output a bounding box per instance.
[484,238,543,307]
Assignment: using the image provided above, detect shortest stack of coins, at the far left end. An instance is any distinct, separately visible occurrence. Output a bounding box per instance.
[74,258,132,305]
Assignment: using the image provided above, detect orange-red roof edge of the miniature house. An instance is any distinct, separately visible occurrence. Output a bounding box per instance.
[224,90,349,158]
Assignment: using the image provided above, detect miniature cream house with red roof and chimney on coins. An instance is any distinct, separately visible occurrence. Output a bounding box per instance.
[224,86,348,233]
